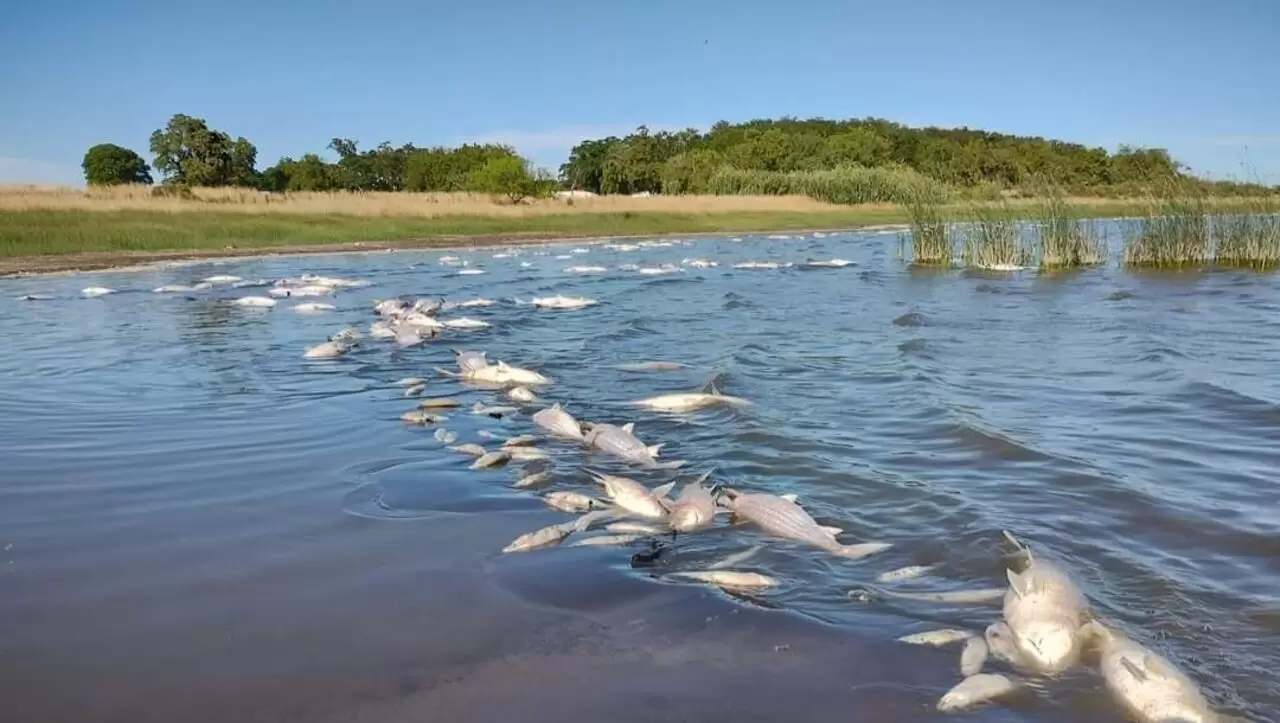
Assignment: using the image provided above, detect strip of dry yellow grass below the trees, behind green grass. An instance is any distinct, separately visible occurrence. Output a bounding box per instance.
[0,186,840,218]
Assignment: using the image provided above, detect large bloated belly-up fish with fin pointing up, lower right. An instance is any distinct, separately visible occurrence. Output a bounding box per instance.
[1004,532,1087,674]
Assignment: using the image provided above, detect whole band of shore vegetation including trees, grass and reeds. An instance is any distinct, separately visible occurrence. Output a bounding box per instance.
[0,114,1280,273]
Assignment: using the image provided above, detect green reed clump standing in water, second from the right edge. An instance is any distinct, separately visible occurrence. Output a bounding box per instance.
[1124,184,1213,269]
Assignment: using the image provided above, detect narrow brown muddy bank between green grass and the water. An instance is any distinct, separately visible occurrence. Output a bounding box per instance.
[0,224,910,279]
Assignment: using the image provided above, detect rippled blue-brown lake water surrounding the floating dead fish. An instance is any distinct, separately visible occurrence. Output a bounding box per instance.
[0,233,1280,722]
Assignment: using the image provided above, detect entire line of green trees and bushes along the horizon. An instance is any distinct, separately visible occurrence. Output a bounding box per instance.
[83,114,1262,202]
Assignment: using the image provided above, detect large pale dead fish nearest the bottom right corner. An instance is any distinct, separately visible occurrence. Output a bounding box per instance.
[1085,621,1221,723]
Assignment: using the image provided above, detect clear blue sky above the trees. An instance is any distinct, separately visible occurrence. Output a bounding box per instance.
[0,0,1280,183]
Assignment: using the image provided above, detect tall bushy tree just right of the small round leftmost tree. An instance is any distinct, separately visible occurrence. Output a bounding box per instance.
[151,113,257,187]
